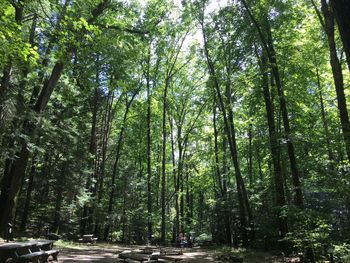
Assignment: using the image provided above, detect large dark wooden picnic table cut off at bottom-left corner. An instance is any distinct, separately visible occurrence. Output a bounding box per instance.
[0,240,59,263]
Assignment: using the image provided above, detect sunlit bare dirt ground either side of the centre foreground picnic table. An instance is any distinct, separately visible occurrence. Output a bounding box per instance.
[59,245,215,263]
